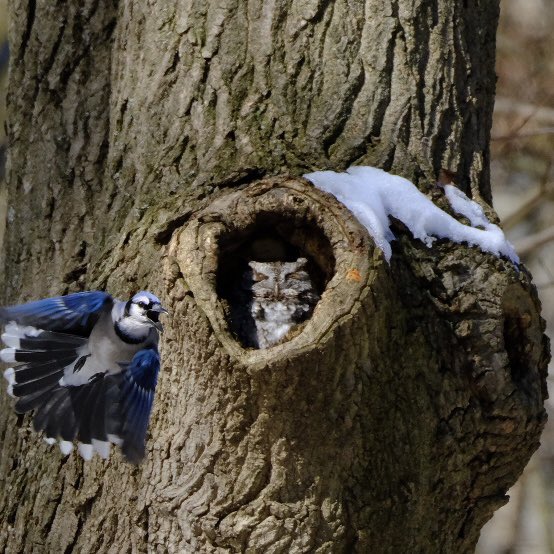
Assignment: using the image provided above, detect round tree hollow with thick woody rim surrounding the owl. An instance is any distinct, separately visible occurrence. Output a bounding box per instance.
[171,178,379,368]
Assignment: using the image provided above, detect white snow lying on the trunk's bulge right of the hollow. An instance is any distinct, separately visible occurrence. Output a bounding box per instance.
[304,166,519,264]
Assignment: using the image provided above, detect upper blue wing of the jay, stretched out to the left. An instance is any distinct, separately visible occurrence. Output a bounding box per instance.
[0,291,113,337]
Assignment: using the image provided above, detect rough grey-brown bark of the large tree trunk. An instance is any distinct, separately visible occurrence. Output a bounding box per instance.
[0,0,548,553]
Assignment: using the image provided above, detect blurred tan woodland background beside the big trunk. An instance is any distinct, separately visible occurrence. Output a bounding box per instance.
[0,0,554,554]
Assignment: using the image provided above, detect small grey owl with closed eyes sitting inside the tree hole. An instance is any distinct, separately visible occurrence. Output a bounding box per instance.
[245,258,319,348]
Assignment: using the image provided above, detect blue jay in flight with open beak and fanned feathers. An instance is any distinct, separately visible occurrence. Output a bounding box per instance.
[0,291,167,464]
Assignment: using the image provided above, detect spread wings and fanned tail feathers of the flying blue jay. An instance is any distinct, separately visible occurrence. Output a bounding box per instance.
[0,291,160,463]
